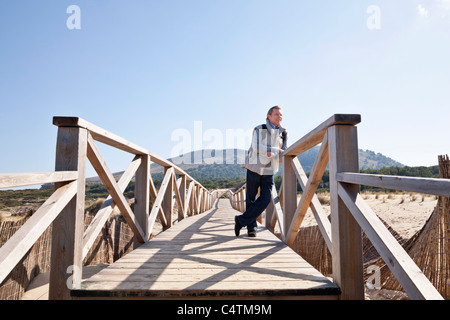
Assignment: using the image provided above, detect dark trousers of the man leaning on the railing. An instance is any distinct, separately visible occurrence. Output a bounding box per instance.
[238,170,274,232]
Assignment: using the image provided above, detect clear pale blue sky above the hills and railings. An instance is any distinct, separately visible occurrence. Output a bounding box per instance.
[0,0,450,174]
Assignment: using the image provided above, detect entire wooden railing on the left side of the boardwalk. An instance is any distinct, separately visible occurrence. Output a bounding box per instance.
[0,117,217,300]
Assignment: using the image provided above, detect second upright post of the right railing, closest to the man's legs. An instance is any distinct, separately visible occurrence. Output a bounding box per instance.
[282,156,297,242]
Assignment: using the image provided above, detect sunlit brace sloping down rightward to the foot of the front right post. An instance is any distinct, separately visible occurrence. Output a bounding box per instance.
[292,158,332,252]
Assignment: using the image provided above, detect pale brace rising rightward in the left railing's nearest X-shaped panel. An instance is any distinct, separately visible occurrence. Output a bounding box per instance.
[83,156,141,259]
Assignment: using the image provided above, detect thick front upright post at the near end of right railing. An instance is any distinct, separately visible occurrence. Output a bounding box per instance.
[328,125,364,300]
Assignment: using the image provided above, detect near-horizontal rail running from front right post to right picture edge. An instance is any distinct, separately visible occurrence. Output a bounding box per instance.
[336,172,450,197]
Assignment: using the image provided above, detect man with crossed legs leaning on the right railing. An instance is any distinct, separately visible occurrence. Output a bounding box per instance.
[234,106,287,237]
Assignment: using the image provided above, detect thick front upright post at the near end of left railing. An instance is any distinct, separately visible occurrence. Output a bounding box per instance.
[49,127,87,300]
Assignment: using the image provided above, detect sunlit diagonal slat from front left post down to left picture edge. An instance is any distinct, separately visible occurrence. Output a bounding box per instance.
[0,181,78,283]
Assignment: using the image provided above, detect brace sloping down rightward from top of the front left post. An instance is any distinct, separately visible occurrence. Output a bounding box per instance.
[87,135,146,243]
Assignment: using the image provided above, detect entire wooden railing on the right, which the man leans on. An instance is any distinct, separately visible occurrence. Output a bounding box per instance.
[230,114,450,299]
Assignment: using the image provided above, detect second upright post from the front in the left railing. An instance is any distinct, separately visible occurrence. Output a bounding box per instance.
[134,155,150,242]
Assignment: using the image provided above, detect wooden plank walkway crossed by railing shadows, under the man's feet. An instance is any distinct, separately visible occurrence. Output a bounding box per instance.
[71,199,339,299]
